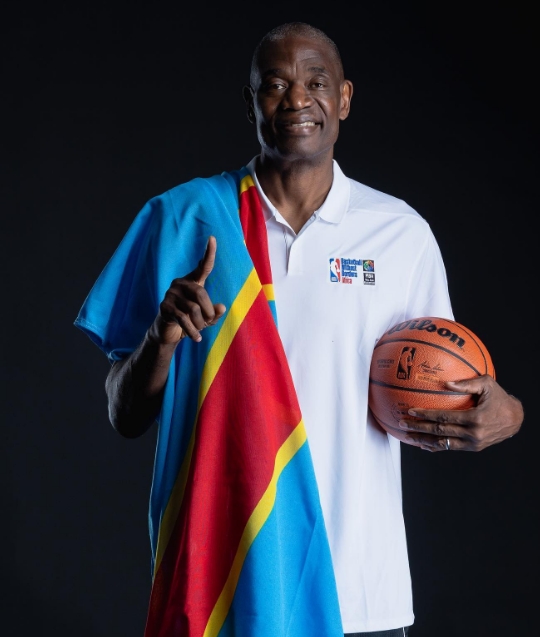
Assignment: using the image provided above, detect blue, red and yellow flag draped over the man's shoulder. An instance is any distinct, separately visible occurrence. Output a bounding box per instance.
[76,168,343,637]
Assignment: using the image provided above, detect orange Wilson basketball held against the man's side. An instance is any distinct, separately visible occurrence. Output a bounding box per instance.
[369,316,495,432]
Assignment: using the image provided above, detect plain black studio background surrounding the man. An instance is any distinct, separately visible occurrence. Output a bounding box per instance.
[0,2,540,637]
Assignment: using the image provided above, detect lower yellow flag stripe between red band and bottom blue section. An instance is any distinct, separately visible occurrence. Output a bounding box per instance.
[203,420,307,637]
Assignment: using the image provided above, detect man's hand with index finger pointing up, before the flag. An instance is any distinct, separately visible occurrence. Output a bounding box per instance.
[148,236,226,345]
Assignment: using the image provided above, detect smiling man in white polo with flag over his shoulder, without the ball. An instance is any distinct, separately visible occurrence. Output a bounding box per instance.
[76,23,523,637]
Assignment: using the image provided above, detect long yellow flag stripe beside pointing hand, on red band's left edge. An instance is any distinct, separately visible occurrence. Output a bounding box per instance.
[154,268,261,576]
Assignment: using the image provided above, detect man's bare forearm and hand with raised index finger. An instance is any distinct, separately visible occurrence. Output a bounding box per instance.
[105,237,225,438]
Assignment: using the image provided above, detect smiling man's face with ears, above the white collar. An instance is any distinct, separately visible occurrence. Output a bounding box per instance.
[244,35,352,160]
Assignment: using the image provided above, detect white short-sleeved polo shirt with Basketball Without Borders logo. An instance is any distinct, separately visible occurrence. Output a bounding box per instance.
[248,157,453,633]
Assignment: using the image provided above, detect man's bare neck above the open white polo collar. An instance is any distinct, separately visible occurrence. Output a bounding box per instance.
[256,155,333,233]
